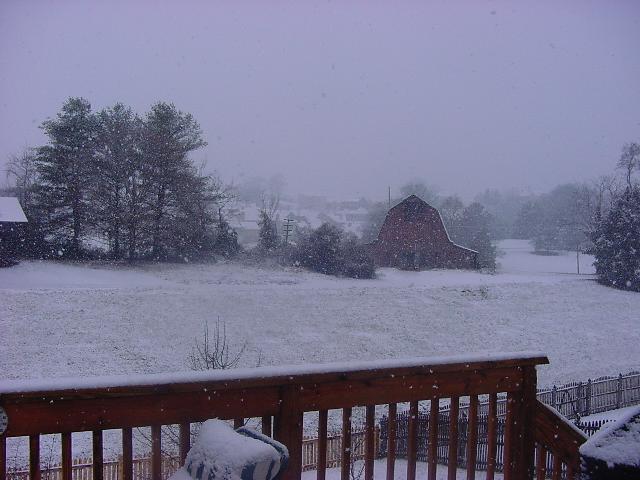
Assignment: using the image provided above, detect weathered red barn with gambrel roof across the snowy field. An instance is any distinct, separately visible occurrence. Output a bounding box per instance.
[370,195,478,270]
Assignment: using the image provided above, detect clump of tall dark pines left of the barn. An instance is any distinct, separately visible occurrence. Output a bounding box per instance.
[4,98,237,260]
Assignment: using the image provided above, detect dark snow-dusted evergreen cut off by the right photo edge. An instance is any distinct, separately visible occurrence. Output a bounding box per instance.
[593,187,640,292]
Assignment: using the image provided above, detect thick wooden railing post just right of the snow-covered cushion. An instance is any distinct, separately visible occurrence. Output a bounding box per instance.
[274,385,303,480]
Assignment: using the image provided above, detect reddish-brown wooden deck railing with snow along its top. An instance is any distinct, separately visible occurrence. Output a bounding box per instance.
[0,354,588,480]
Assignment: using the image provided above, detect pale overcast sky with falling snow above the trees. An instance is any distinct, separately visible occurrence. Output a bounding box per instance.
[0,0,640,198]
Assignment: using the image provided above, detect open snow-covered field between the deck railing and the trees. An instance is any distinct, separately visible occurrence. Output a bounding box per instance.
[0,240,640,384]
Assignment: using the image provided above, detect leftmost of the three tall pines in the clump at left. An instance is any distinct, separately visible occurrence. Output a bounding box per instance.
[36,98,99,257]
